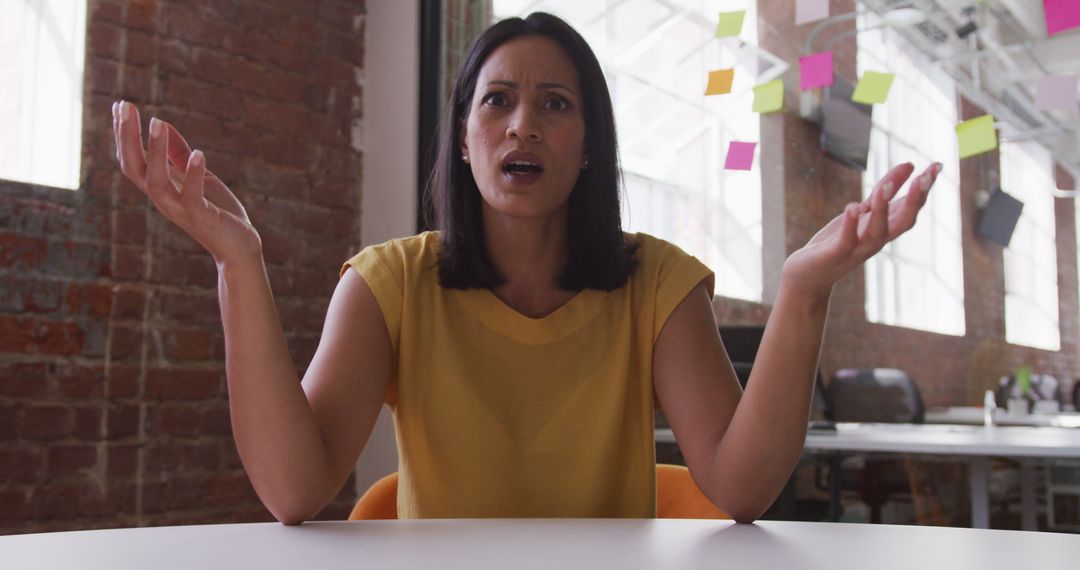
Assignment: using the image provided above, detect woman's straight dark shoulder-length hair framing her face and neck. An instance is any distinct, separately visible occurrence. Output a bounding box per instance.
[424,12,637,290]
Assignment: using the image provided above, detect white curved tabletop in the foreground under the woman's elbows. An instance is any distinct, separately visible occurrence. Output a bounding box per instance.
[0,519,1080,570]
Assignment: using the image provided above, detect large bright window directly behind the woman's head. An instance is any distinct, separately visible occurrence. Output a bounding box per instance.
[494,0,770,301]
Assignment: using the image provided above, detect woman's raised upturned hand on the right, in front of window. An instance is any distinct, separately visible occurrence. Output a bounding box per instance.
[782,162,942,299]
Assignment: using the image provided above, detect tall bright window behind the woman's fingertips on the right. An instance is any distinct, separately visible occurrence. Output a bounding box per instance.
[858,13,964,336]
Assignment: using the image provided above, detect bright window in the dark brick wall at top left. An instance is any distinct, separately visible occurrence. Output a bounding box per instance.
[0,0,86,190]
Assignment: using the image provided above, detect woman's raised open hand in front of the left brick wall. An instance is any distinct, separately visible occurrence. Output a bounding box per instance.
[112,101,262,267]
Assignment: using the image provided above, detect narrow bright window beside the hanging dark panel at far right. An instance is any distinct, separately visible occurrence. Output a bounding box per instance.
[1000,143,1061,351]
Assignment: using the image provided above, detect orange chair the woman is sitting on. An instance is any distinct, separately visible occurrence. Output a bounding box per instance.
[349,463,731,520]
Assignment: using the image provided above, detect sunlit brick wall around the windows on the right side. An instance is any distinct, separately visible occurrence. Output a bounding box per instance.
[730,0,1080,406]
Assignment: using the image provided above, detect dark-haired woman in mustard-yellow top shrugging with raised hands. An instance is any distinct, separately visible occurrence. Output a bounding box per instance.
[107,13,941,524]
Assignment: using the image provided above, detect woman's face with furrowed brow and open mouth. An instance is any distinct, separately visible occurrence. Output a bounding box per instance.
[460,36,585,218]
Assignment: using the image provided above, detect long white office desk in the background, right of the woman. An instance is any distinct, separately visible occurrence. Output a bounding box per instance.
[656,423,1080,530]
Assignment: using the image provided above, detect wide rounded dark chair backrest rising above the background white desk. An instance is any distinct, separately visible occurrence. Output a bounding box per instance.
[825,368,926,423]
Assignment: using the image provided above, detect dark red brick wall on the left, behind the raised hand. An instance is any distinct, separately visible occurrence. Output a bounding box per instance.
[0,0,365,533]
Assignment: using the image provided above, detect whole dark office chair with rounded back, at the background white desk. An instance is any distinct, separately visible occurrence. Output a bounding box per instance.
[825,368,948,525]
